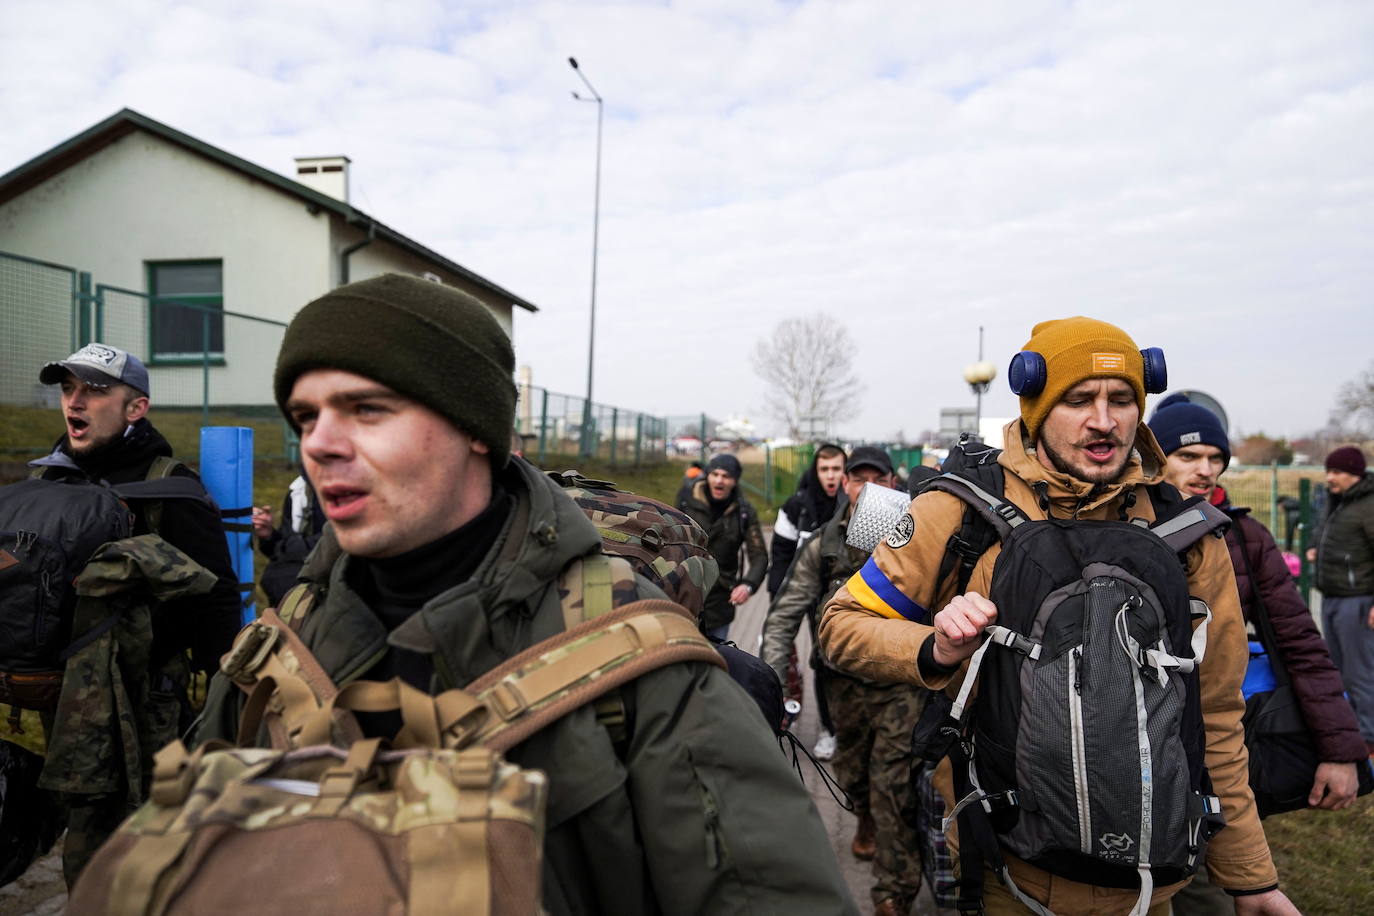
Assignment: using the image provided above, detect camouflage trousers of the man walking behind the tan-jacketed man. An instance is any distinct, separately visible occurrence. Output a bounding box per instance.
[822,674,926,912]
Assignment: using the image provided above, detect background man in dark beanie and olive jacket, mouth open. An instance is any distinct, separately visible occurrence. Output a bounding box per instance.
[677,455,768,641]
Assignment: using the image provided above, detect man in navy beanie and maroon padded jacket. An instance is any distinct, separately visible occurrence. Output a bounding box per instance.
[1150,394,1367,916]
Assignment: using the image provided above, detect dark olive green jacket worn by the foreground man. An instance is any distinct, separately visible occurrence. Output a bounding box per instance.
[196,459,855,915]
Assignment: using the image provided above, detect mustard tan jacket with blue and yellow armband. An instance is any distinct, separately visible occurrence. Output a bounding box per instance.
[820,420,1278,912]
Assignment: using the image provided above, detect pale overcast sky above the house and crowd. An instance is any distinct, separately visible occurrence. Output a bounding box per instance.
[0,0,1374,437]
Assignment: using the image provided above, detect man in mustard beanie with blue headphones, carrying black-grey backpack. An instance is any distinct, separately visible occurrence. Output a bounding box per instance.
[819,317,1297,916]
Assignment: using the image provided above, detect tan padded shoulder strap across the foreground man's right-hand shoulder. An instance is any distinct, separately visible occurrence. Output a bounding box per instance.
[458,599,725,751]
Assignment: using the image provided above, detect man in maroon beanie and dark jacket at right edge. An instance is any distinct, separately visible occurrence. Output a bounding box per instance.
[1308,445,1374,755]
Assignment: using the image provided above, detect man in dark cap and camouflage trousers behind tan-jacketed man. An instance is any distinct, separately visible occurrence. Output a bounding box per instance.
[763,445,926,916]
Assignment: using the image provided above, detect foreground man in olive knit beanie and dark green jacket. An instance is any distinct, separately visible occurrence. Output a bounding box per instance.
[196,275,853,913]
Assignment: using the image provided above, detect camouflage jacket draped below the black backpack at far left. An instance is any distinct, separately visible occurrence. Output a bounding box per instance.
[38,534,216,810]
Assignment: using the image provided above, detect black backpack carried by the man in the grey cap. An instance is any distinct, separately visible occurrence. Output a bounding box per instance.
[0,468,209,710]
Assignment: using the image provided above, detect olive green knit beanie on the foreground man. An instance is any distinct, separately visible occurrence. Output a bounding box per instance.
[273,273,515,470]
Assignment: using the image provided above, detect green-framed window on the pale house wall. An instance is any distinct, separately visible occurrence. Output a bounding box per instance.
[147,260,224,363]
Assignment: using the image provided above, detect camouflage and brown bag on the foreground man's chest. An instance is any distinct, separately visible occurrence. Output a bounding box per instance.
[67,739,547,916]
